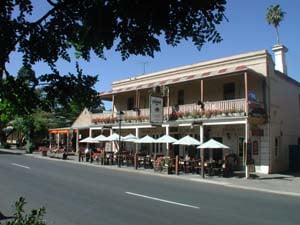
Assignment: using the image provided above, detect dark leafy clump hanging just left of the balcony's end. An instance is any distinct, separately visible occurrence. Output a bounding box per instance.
[40,64,104,121]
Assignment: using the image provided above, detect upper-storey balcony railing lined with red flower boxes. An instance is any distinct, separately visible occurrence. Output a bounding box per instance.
[93,99,251,124]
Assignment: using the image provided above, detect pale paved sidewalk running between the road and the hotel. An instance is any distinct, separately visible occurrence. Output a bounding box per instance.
[0,149,300,197]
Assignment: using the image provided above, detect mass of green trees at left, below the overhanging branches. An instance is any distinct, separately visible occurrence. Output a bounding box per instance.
[0,64,104,147]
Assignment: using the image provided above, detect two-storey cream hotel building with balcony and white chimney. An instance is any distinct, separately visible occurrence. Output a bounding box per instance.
[73,45,300,173]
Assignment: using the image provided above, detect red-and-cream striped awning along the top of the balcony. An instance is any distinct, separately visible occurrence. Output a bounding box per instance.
[99,65,249,97]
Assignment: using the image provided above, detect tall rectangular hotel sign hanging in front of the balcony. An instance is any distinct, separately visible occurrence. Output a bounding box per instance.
[149,95,163,126]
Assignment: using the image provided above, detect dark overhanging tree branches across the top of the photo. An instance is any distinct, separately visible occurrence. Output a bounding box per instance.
[0,0,226,77]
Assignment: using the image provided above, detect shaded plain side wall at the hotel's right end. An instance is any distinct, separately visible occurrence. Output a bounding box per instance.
[270,69,300,172]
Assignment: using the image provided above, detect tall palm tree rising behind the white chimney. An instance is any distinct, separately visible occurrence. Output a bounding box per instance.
[266,5,285,44]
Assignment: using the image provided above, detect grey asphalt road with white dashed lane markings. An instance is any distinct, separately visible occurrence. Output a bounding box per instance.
[0,153,300,225]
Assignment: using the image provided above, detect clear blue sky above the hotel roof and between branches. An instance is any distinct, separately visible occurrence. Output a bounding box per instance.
[7,0,300,109]
